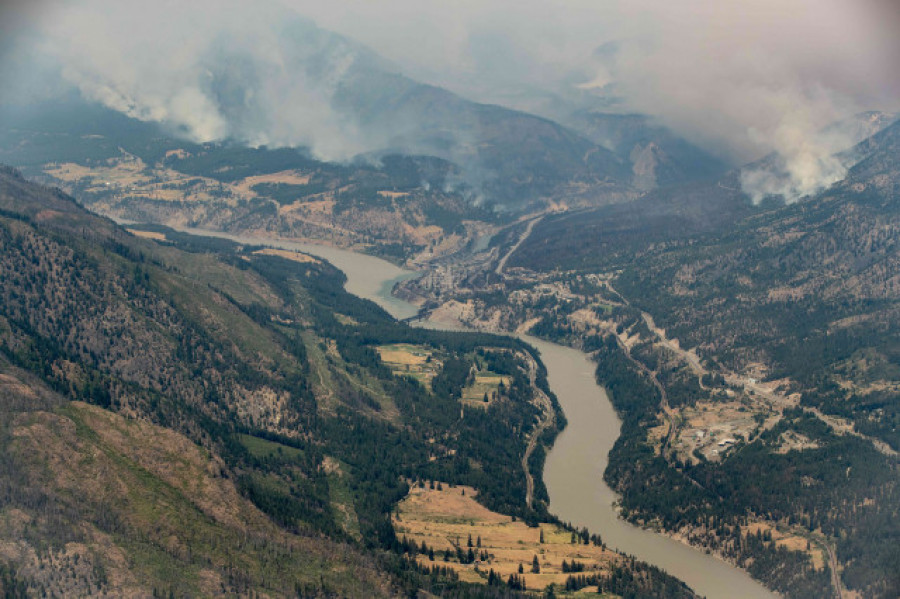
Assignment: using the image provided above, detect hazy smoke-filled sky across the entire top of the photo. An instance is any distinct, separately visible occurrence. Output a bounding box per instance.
[0,0,900,202]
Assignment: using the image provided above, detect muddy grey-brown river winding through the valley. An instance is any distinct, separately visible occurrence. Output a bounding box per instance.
[165,229,776,599]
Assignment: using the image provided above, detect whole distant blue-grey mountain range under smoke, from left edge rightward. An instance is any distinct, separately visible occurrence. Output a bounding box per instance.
[0,11,724,211]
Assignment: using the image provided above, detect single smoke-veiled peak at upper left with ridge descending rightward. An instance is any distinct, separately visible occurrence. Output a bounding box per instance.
[4,6,628,210]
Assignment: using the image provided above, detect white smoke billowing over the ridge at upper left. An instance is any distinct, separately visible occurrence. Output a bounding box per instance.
[28,0,385,160]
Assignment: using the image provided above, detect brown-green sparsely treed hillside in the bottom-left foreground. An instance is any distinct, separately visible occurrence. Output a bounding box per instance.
[0,392,393,596]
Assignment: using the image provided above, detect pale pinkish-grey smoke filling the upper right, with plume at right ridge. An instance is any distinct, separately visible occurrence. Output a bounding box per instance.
[282,0,900,201]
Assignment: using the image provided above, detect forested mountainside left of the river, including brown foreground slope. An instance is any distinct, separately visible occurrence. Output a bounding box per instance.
[0,163,556,597]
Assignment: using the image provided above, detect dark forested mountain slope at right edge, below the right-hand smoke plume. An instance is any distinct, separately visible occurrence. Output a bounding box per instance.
[619,120,900,449]
